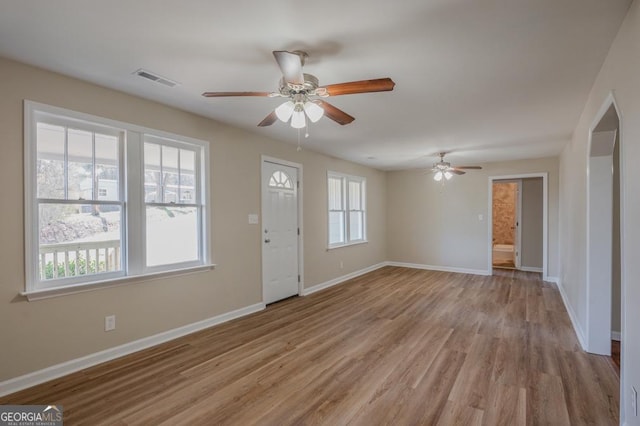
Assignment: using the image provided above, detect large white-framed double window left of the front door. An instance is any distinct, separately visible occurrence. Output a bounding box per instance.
[25,102,210,295]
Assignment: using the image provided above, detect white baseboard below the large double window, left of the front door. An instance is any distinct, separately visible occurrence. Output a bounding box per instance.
[0,303,265,396]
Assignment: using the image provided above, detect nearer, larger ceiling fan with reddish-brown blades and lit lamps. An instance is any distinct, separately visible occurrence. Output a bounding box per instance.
[202,50,395,129]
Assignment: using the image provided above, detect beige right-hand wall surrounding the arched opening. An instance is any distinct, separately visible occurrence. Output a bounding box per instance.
[559,1,640,424]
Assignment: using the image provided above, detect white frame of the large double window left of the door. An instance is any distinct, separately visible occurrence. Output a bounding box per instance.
[22,100,215,300]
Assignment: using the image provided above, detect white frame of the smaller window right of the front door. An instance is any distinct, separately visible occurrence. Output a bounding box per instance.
[327,171,368,249]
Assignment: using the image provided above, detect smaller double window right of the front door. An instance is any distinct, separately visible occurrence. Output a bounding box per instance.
[327,172,367,248]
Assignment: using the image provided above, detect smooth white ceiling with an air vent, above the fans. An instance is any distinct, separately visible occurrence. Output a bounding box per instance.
[0,0,631,170]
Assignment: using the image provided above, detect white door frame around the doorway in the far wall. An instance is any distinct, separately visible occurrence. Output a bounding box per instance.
[487,172,550,281]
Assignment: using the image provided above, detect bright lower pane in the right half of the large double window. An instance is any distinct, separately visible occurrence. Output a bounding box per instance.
[146,206,199,266]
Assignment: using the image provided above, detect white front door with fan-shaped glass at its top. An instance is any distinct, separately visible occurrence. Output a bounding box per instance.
[262,160,299,303]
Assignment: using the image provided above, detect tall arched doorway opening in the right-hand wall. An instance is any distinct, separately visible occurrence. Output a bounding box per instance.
[586,95,624,366]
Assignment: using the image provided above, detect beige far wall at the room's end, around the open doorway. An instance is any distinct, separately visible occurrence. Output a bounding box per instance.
[387,158,558,277]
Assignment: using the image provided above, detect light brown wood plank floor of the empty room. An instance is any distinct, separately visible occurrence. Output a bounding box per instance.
[0,267,619,426]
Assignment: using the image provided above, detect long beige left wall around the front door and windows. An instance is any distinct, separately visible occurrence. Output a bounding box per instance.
[0,59,386,381]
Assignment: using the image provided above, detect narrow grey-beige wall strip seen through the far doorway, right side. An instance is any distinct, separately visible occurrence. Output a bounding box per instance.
[520,178,543,268]
